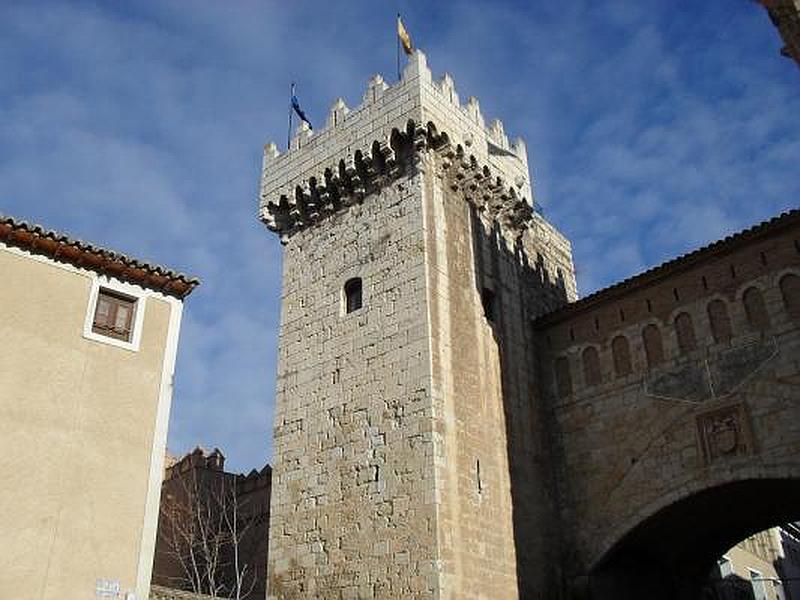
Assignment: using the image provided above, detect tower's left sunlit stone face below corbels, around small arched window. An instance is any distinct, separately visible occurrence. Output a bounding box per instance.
[269,175,439,598]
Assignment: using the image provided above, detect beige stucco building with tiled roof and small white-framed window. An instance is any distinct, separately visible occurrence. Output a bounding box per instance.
[0,217,198,600]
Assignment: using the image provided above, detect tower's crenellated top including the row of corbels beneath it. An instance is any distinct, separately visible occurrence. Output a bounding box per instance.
[260,50,533,239]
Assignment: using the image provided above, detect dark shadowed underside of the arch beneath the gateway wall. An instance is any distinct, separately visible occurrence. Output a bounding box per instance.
[580,478,800,600]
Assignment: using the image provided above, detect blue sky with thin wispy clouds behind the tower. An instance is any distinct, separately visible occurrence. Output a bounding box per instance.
[0,0,800,470]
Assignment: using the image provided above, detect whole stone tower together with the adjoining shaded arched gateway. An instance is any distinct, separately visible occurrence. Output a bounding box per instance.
[261,51,800,599]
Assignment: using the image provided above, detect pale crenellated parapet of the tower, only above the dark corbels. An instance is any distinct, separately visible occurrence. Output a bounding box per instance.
[261,51,544,241]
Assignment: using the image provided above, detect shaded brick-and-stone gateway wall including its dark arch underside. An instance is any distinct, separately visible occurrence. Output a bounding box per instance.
[536,211,800,597]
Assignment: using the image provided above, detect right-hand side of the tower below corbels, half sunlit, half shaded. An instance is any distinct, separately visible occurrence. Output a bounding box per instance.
[422,148,574,598]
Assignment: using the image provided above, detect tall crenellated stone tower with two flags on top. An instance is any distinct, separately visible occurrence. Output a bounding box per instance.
[260,51,575,599]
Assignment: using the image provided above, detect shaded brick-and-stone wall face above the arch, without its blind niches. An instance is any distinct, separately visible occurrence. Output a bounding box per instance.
[538,211,800,575]
